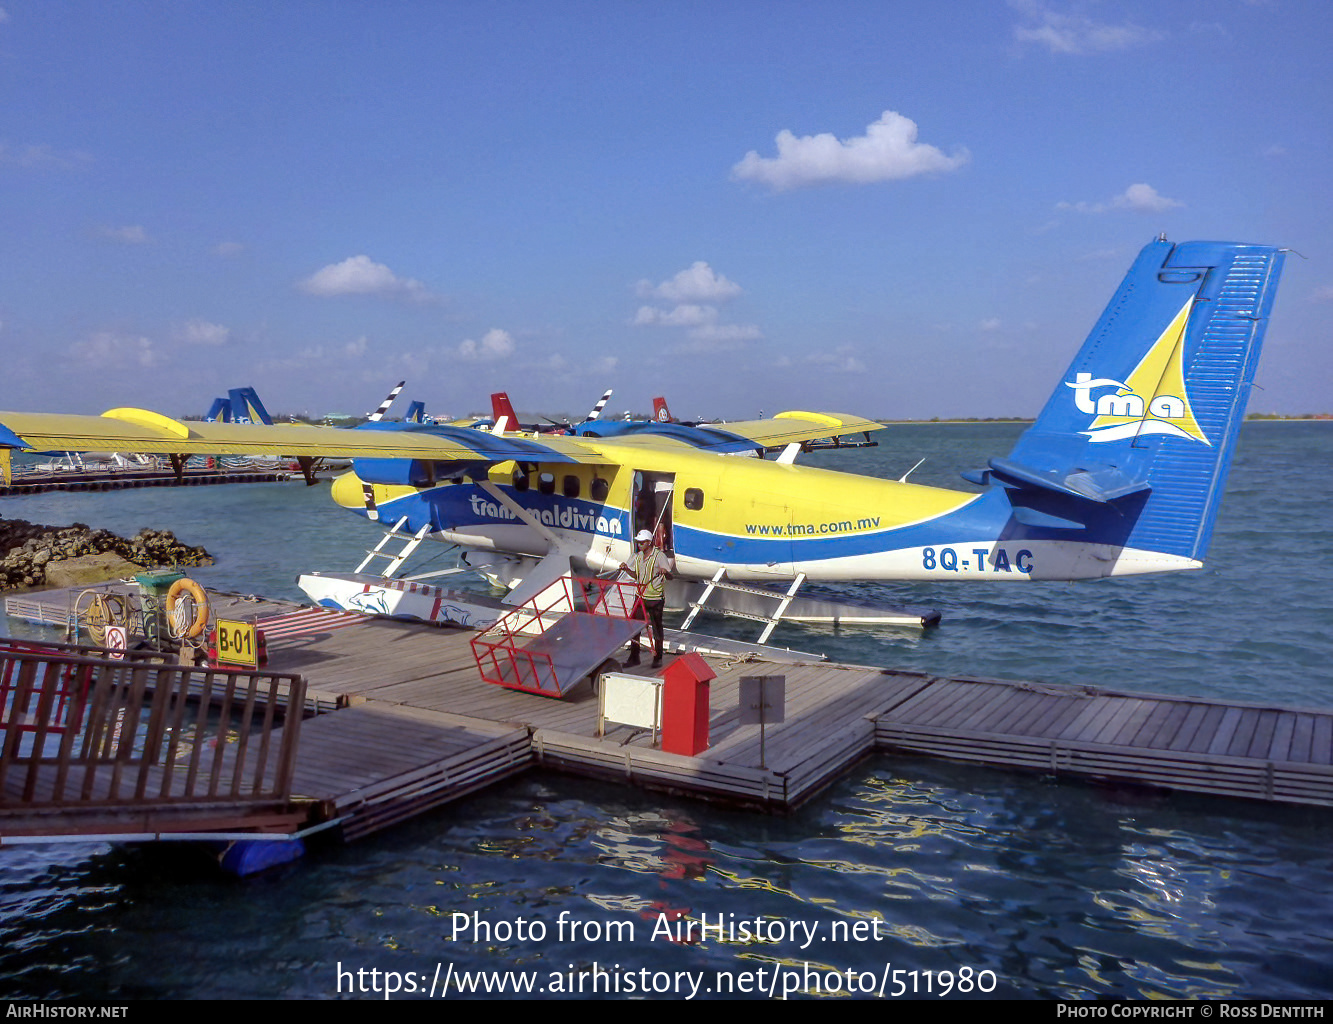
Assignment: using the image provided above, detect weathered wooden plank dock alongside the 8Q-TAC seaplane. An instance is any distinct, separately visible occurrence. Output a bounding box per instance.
[8,581,1333,837]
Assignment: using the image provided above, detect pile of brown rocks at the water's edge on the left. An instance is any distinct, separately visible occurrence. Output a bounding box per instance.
[0,519,213,591]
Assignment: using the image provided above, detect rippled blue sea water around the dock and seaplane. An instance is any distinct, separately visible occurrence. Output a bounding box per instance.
[0,423,1333,999]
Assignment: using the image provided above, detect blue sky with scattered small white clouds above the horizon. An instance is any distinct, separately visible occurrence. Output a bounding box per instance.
[0,0,1333,417]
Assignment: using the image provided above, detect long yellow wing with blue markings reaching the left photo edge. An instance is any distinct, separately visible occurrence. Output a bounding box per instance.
[0,408,607,464]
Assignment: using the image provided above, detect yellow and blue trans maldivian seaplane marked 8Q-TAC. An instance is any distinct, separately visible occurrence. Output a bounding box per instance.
[0,239,1284,640]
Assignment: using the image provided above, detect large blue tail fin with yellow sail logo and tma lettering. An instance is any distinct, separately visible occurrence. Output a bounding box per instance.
[986,239,1282,571]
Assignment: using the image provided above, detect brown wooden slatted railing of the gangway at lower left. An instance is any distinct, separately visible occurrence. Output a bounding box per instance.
[0,640,305,812]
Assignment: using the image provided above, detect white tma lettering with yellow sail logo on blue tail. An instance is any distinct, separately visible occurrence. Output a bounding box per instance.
[1065,300,1212,445]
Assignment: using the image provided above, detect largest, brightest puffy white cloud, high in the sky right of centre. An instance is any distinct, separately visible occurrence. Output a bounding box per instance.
[732,111,969,192]
